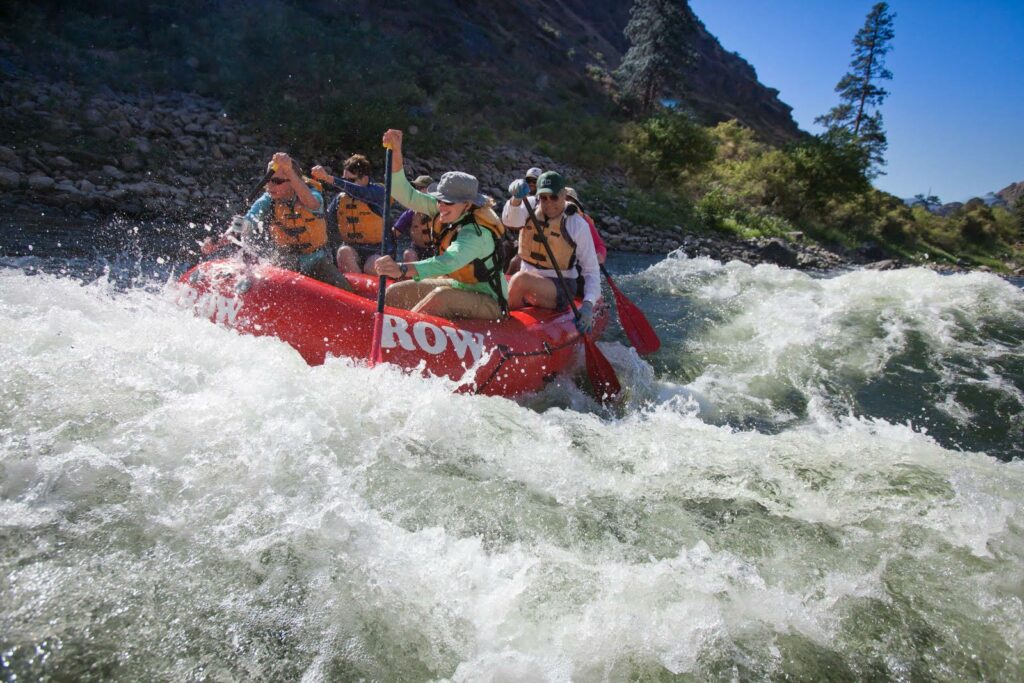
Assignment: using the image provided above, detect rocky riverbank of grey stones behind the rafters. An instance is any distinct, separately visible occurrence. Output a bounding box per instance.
[0,78,873,269]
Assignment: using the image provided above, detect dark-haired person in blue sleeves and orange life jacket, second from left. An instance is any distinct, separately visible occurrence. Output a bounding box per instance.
[312,155,384,274]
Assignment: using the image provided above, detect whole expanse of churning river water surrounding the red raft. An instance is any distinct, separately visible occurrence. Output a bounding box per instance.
[0,222,1024,681]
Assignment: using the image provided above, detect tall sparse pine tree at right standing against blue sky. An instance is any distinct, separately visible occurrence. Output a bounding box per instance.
[814,2,896,176]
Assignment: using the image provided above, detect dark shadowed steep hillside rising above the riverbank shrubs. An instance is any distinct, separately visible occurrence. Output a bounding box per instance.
[0,0,799,148]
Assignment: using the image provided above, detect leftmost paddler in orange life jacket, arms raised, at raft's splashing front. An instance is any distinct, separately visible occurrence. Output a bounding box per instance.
[203,152,352,291]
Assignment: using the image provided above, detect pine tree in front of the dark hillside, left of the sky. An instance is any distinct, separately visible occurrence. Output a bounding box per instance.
[614,0,696,114]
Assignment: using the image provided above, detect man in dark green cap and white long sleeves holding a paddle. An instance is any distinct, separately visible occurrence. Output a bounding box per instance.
[503,171,601,334]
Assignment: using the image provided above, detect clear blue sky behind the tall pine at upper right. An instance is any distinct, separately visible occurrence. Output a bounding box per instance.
[690,0,1024,202]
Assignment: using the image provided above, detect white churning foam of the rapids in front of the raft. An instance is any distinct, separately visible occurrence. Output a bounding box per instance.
[0,264,1024,681]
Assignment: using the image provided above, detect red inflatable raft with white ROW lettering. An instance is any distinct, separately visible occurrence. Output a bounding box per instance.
[181,259,607,396]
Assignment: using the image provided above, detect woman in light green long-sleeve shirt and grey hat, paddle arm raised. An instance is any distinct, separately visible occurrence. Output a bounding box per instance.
[375,130,508,319]
